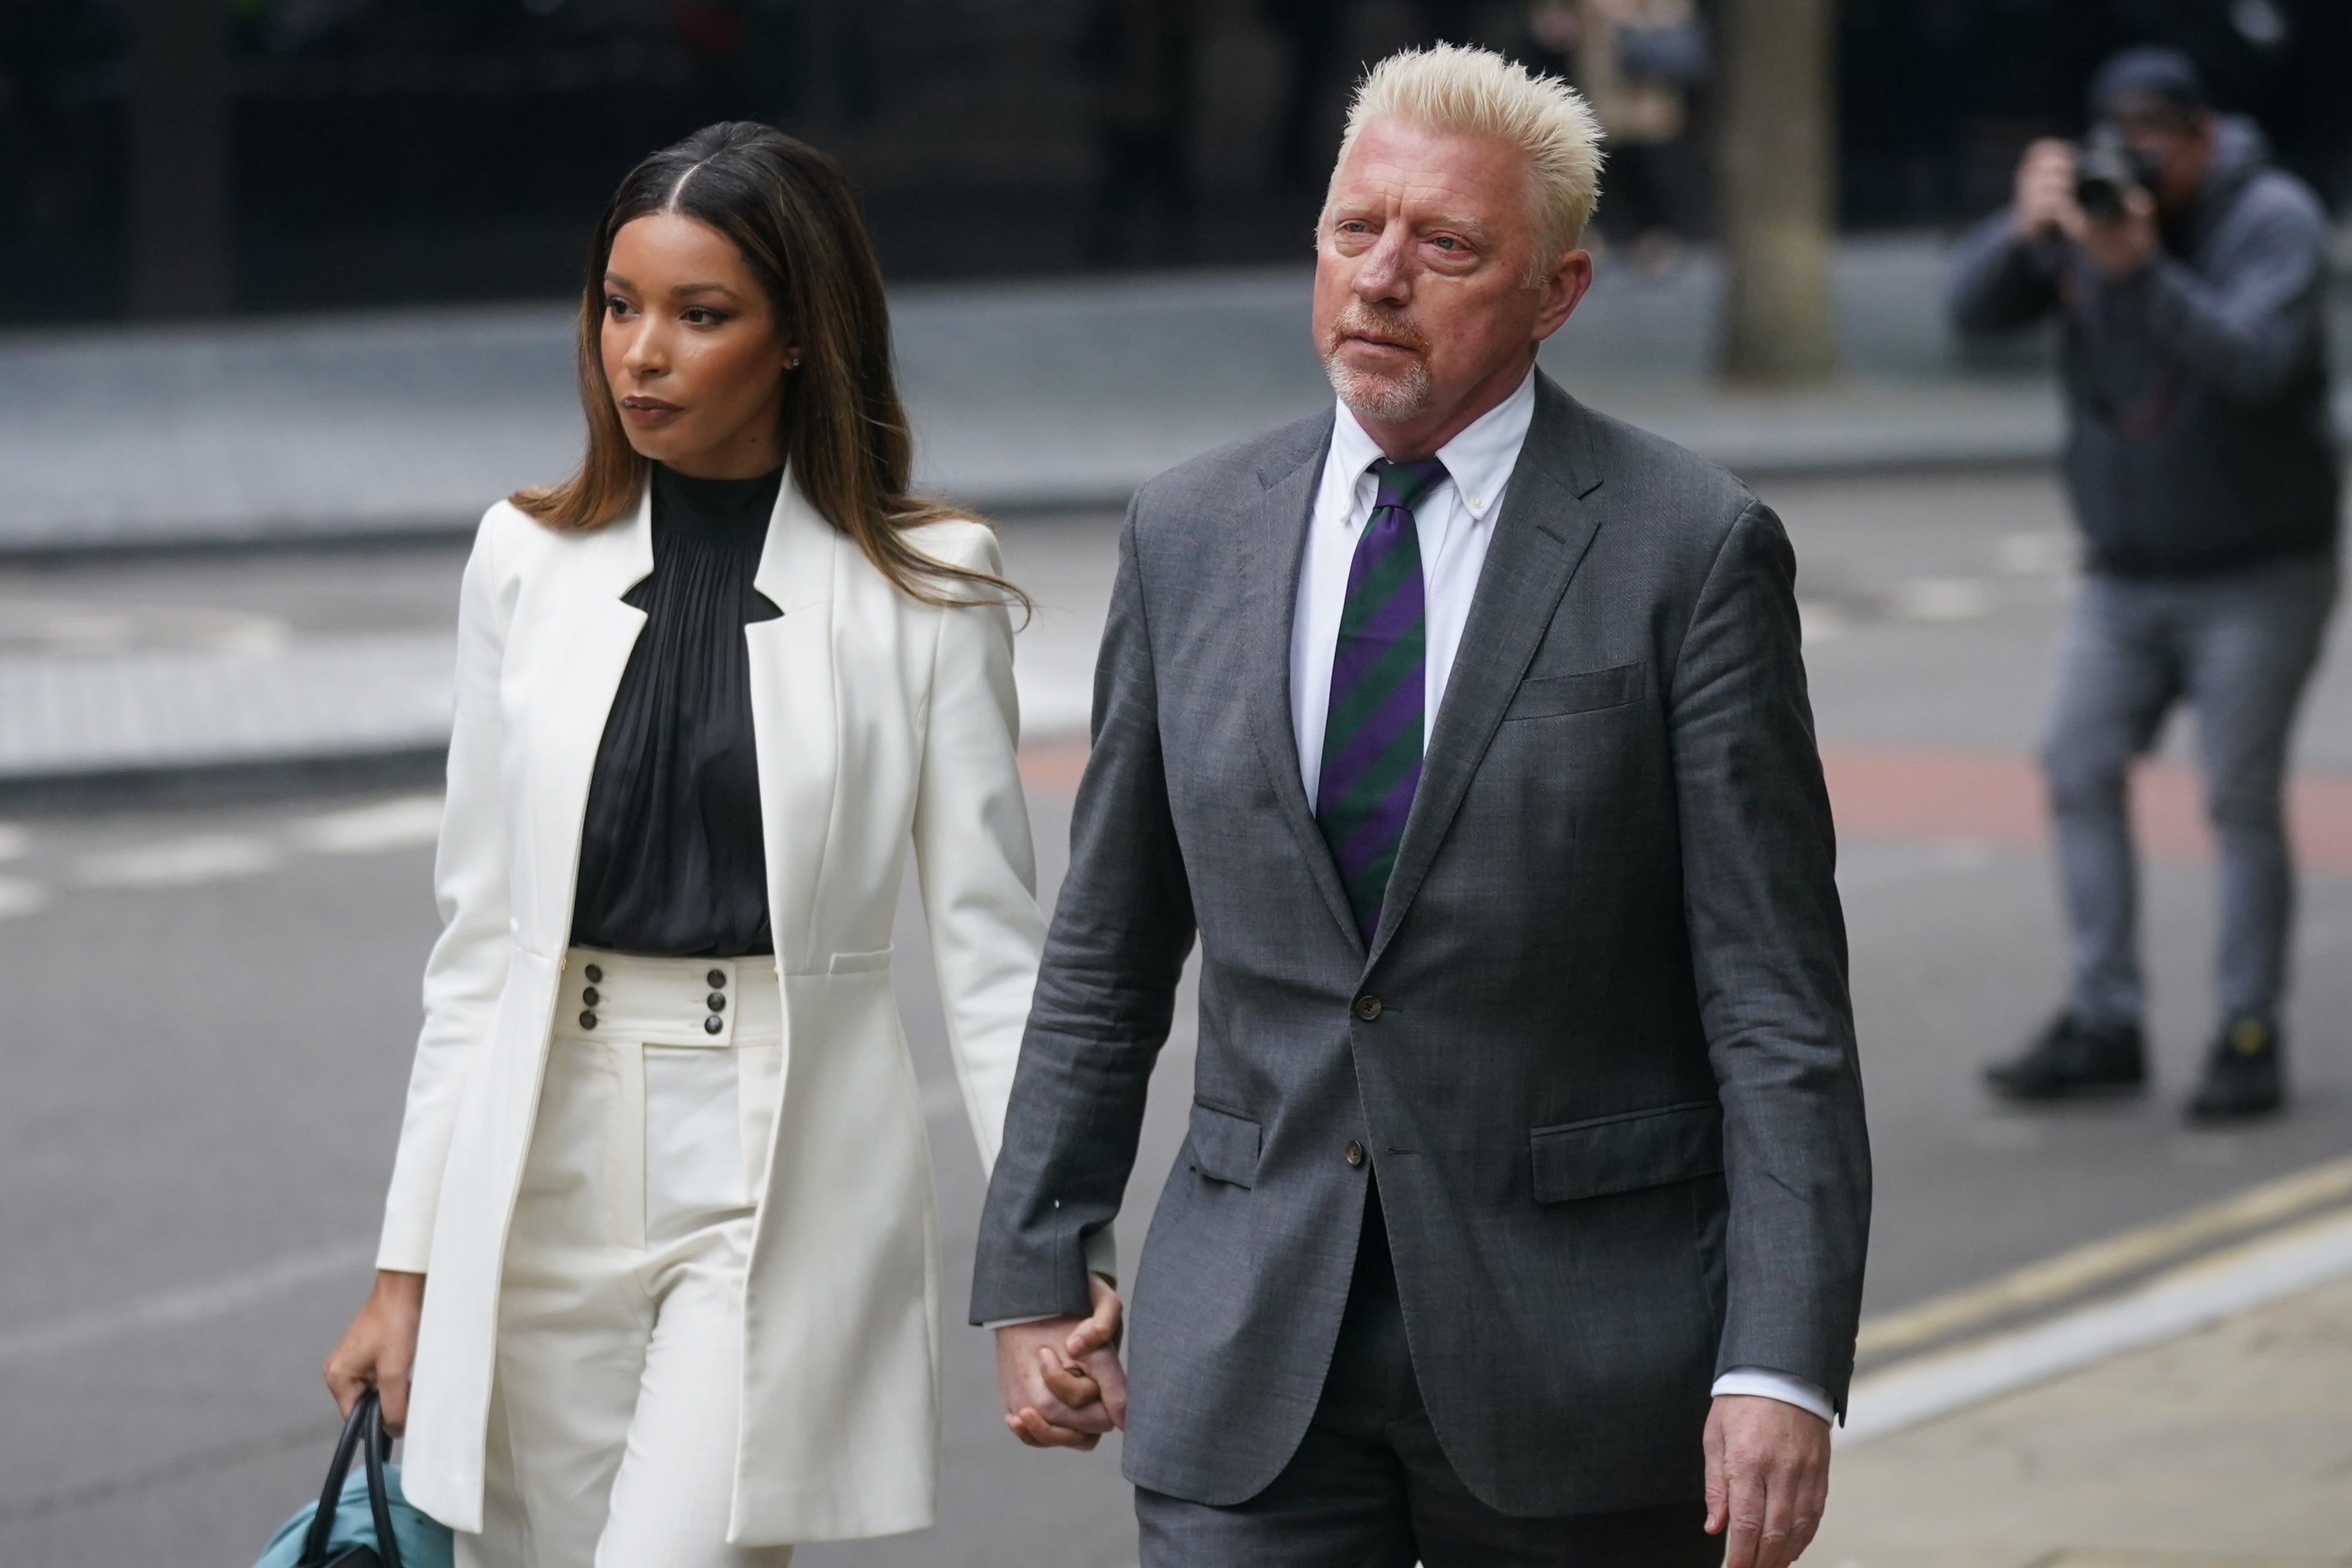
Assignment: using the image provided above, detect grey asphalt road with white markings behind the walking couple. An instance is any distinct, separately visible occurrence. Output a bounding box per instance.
[0,473,2352,1568]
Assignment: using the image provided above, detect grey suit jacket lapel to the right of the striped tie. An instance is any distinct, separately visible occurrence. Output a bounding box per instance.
[1367,374,1601,966]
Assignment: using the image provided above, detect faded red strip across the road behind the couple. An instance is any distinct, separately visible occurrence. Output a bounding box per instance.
[1021,740,2352,872]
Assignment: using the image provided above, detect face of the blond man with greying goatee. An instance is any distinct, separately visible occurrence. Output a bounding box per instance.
[1315,120,1592,439]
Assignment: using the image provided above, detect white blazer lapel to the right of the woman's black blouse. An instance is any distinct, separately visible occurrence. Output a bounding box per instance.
[743,473,844,973]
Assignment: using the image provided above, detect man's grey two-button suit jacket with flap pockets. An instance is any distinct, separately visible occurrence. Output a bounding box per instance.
[972,381,1870,1514]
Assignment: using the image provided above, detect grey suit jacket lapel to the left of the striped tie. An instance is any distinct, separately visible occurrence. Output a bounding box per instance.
[1239,418,1364,947]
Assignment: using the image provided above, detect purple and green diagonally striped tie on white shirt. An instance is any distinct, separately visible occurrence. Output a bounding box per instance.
[1315,458,1447,947]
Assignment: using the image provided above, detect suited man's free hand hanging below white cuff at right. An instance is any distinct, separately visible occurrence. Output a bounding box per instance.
[1708,1394,1830,1568]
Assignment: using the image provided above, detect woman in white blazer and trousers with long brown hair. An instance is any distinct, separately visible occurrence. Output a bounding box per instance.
[327,125,1115,1568]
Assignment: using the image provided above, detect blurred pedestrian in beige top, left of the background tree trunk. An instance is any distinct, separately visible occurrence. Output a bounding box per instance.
[1529,0,1710,277]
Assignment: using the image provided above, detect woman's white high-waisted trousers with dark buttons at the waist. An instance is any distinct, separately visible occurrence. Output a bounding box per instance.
[457,947,792,1568]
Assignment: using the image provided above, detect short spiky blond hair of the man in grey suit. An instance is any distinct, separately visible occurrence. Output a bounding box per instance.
[1334,45,1601,275]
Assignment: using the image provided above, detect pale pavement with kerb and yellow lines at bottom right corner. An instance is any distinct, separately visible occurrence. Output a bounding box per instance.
[1809,1159,2352,1568]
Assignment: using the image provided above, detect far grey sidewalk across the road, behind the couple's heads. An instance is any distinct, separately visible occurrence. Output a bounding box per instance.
[0,237,2097,552]
